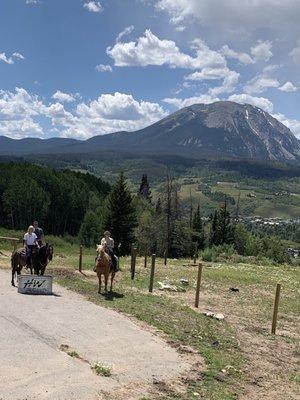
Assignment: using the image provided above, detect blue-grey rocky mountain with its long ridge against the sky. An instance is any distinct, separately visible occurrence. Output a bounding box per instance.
[0,101,300,161]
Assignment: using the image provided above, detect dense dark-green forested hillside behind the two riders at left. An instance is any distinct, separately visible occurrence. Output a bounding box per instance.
[0,163,110,235]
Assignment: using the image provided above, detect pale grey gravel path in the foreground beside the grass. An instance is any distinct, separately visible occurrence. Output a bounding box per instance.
[0,270,189,400]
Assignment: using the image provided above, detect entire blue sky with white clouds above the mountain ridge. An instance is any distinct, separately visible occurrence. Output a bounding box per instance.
[0,0,300,139]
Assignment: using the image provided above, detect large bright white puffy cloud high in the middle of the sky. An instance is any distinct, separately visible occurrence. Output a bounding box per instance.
[107,29,226,69]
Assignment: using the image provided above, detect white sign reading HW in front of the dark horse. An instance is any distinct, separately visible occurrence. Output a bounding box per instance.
[18,275,53,294]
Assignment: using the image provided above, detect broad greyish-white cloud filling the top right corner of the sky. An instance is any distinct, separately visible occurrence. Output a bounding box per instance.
[155,0,300,36]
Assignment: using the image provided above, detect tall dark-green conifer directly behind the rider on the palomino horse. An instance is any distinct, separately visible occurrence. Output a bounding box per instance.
[105,174,137,255]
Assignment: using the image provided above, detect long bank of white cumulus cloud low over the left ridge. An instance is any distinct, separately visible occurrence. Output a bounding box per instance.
[0,88,167,139]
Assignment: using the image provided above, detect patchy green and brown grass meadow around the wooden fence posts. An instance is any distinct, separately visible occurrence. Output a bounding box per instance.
[0,230,300,400]
